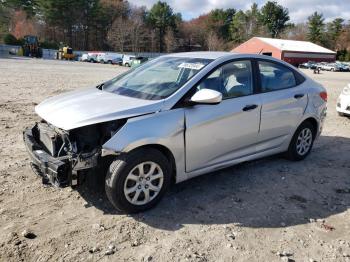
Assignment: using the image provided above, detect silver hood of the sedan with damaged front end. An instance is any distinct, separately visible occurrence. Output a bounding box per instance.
[35,88,162,130]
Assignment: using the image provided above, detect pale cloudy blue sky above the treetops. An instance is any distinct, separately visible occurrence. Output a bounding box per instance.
[129,0,350,23]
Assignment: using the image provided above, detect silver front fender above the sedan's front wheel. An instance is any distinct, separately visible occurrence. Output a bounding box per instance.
[102,108,186,182]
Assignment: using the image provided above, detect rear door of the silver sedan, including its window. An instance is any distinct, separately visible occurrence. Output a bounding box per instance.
[257,60,308,151]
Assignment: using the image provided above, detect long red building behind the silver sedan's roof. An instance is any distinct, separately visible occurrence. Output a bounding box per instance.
[232,37,336,66]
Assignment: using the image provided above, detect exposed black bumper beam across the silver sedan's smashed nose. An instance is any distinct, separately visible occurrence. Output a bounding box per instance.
[23,127,72,187]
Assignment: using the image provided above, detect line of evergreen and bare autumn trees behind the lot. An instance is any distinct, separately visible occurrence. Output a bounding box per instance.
[0,0,350,60]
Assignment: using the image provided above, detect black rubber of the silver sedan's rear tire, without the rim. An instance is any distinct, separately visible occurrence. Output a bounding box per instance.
[286,121,316,161]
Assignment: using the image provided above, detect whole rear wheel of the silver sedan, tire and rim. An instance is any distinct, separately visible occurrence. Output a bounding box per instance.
[287,122,316,161]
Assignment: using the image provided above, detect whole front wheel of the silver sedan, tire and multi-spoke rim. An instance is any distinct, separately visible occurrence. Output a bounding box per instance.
[105,148,171,213]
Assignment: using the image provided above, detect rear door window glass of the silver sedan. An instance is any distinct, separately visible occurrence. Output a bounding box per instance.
[259,61,297,92]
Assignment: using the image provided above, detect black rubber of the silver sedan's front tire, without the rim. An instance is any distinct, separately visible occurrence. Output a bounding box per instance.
[105,148,171,213]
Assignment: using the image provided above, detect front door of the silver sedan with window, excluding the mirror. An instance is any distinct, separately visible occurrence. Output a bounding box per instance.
[185,60,261,172]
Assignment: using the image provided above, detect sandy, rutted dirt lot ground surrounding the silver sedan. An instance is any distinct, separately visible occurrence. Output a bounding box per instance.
[0,56,350,262]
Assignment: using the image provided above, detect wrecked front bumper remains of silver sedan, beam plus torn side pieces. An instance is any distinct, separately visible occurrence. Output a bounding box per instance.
[23,125,101,187]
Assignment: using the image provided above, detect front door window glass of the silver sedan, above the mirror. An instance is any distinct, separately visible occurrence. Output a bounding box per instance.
[197,60,253,99]
